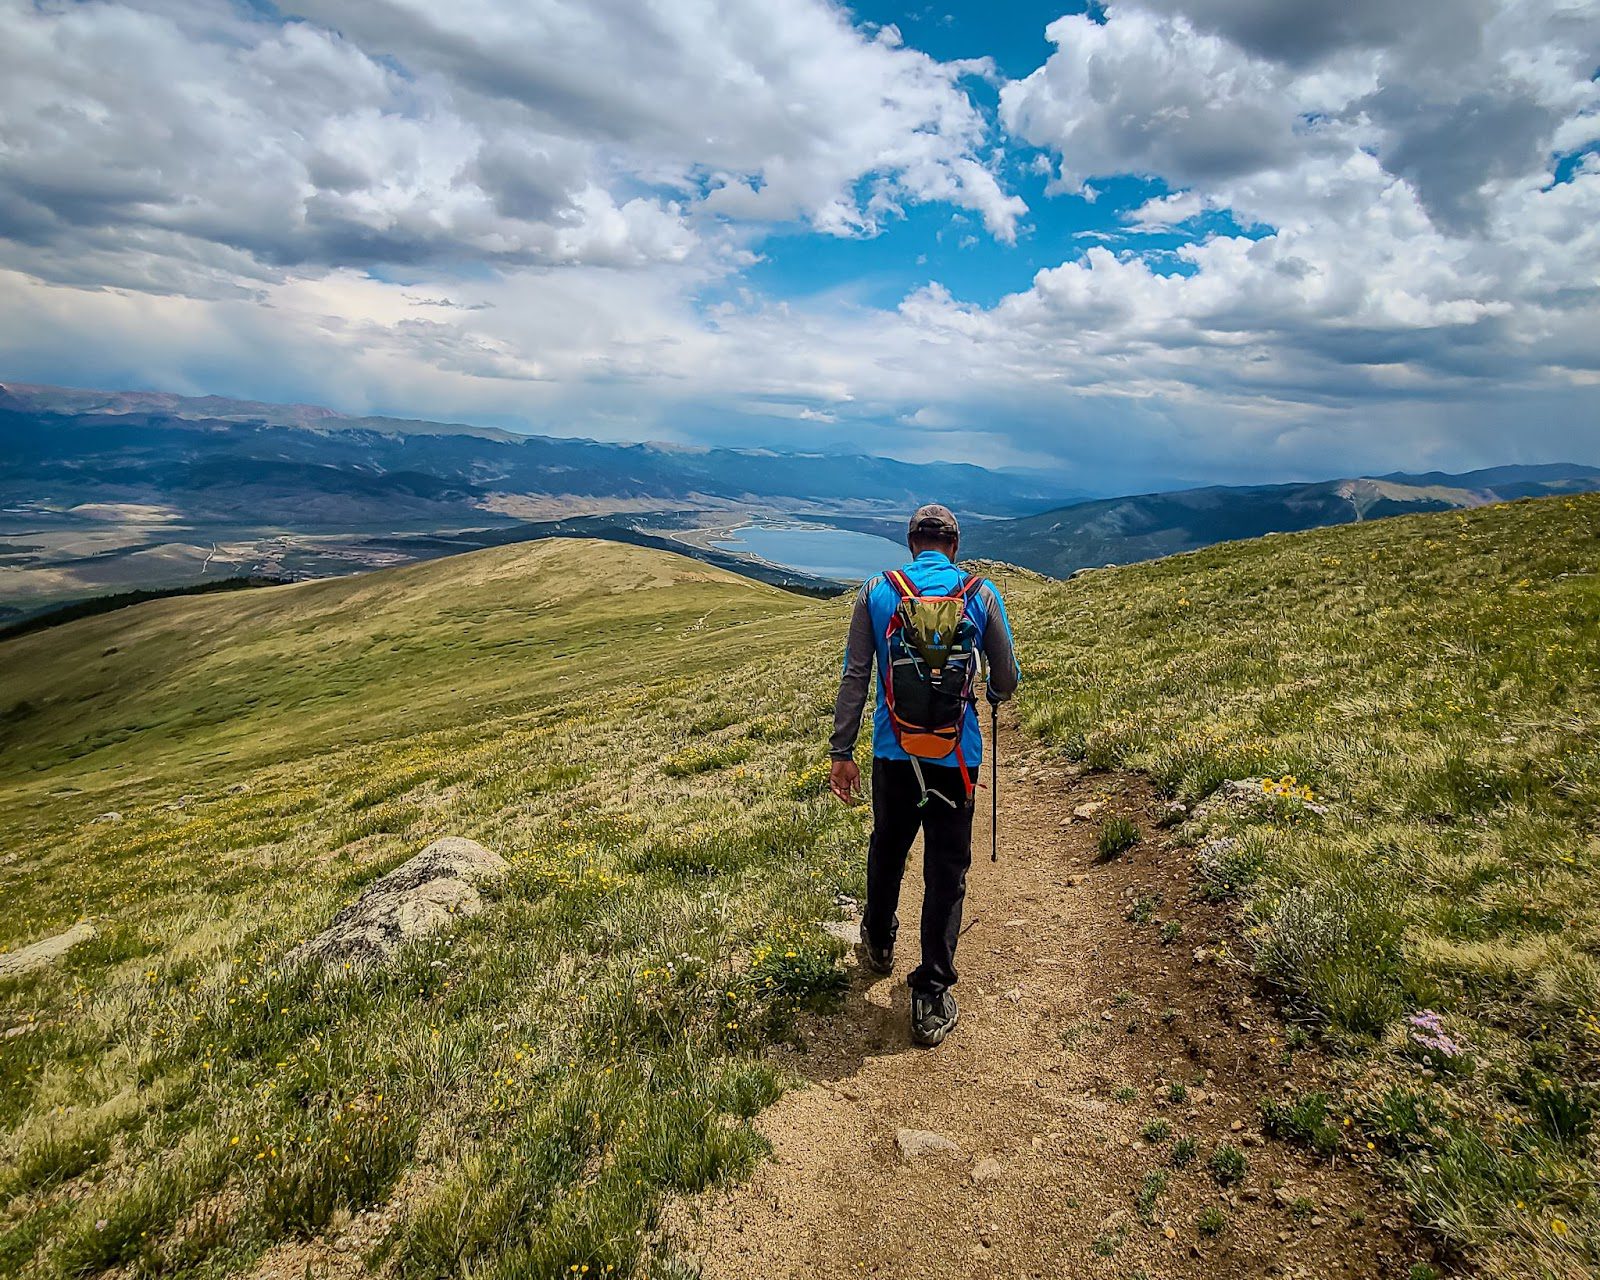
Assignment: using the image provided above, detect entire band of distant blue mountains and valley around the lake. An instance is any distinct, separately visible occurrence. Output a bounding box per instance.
[0,382,1600,622]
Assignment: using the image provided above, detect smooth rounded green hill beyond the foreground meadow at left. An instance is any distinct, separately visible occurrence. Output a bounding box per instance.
[0,541,805,787]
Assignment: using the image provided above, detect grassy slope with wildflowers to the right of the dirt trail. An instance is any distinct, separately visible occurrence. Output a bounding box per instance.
[1026,496,1600,1277]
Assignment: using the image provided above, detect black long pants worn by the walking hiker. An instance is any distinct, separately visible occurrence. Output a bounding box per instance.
[861,757,973,995]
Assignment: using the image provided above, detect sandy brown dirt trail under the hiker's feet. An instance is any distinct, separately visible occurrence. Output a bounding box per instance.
[672,731,1427,1280]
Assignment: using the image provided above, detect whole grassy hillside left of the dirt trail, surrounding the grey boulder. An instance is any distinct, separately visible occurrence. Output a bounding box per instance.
[0,541,859,1277]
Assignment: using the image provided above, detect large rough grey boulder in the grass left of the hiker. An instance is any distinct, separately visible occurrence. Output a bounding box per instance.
[286,835,510,968]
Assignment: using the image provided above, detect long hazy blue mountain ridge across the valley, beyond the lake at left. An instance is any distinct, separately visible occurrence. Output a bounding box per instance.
[0,384,1072,525]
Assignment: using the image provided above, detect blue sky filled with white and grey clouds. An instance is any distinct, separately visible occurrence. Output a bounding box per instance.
[0,0,1600,491]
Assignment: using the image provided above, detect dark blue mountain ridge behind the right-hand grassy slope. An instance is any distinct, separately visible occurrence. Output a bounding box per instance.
[963,462,1600,578]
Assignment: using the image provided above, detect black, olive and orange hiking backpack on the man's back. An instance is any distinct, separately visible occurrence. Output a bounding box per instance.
[883,570,984,803]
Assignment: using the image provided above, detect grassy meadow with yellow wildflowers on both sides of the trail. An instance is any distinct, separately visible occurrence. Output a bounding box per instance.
[0,496,1600,1278]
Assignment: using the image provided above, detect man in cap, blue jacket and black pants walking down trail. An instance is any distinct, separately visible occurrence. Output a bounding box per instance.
[829,504,1019,1045]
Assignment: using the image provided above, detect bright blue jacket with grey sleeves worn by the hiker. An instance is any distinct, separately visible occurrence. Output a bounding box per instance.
[829,550,1021,770]
